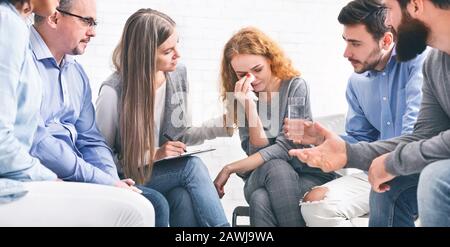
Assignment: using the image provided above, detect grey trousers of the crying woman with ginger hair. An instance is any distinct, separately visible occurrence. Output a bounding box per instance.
[244,160,335,227]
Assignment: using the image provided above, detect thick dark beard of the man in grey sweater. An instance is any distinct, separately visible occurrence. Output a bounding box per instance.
[395,11,430,62]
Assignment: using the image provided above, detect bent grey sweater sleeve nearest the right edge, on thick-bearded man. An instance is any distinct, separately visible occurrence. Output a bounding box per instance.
[386,51,450,175]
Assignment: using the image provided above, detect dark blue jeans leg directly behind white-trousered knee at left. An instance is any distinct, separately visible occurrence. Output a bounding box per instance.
[137,186,169,227]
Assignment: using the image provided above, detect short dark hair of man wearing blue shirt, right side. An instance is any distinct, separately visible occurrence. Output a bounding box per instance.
[338,0,391,40]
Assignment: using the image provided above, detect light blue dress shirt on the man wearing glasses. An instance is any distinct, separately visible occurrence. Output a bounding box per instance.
[30,27,119,185]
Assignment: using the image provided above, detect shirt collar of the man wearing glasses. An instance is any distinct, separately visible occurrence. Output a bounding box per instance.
[30,26,75,68]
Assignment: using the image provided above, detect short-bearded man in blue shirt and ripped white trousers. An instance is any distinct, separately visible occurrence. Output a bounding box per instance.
[301,0,426,226]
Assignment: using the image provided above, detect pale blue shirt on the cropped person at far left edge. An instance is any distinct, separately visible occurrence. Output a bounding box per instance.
[0,2,56,182]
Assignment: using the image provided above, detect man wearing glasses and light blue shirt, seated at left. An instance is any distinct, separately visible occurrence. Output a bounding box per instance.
[30,0,140,189]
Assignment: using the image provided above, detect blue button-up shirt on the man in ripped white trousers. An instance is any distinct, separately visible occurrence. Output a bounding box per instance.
[343,49,429,143]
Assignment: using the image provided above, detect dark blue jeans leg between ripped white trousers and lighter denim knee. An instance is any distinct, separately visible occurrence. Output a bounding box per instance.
[369,174,419,227]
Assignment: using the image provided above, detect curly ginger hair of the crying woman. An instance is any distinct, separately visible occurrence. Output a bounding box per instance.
[220,27,300,126]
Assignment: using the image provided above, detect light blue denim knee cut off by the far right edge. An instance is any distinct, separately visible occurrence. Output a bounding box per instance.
[417,160,450,227]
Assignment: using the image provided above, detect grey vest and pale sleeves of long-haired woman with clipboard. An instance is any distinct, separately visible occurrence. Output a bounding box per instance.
[96,65,229,164]
